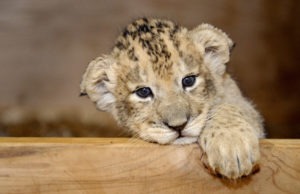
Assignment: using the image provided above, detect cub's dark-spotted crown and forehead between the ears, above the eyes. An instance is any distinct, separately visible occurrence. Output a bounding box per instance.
[112,18,202,77]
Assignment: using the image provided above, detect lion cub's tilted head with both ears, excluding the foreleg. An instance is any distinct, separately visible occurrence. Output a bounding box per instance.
[80,18,233,144]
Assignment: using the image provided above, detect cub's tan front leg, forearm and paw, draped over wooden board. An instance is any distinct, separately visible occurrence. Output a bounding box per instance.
[198,104,261,179]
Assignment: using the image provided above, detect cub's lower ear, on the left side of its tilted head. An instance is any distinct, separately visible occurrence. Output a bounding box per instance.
[80,56,115,112]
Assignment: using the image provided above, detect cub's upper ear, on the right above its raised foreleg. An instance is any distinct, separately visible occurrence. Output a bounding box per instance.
[189,24,234,74]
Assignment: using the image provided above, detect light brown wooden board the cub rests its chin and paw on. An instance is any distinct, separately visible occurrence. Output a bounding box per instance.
[0,138,300,194]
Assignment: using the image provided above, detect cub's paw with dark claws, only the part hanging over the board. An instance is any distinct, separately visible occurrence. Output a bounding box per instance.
[200,133,260,179]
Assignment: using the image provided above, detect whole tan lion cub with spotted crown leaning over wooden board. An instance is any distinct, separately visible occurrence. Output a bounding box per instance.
[80,18,263,179]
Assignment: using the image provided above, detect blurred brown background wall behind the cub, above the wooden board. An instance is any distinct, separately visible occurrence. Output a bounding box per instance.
[0,0,300,138]
